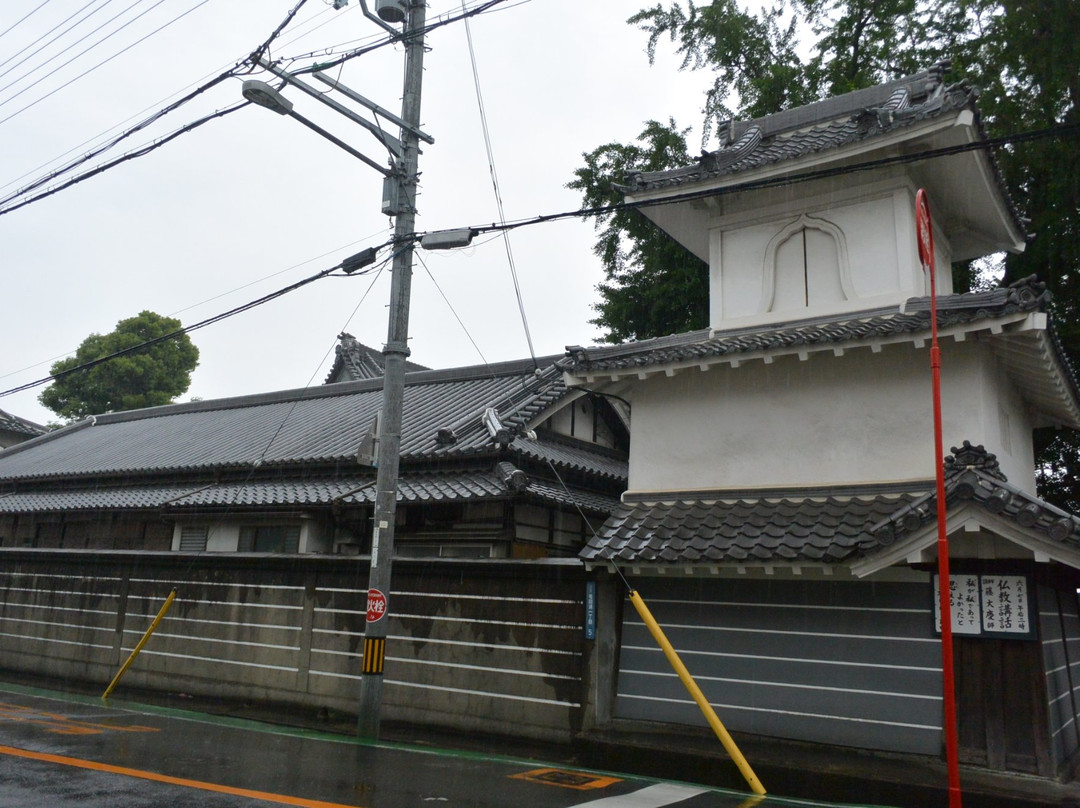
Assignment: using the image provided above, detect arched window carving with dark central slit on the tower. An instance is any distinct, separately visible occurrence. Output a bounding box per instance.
[758,215,855,313]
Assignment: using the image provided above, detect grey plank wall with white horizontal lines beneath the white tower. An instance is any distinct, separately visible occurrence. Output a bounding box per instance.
[616,578,942,755]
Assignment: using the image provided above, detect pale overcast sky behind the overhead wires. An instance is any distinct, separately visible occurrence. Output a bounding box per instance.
[0,0,710,422]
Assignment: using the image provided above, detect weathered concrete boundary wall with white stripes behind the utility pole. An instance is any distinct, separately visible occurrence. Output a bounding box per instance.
[0,550,586,741]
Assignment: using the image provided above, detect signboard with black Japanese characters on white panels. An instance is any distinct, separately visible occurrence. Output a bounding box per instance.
[934,574,1036,639]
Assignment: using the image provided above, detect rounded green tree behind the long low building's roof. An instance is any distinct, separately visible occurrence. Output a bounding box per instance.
[38,311,199,420]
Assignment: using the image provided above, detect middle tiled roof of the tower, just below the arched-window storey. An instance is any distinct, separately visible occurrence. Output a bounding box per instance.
[566,278,1050,376]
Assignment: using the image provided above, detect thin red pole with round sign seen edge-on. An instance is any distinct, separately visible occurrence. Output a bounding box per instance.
[915,188,960,808]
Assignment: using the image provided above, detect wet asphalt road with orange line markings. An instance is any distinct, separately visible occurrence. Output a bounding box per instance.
[0,685,881,808]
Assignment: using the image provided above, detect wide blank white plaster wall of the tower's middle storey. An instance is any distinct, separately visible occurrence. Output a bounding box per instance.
[630,342,1034,491]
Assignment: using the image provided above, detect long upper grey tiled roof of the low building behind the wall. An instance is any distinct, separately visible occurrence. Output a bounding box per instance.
[0,358,626,485]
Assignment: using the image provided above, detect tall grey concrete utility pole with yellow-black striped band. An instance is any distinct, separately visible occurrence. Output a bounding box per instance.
[356,0,426,739]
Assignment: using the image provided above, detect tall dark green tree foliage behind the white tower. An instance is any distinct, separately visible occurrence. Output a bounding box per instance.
[570,0,1080,511]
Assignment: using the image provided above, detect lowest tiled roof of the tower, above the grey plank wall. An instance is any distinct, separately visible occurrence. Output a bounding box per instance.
[580,442,1080,567]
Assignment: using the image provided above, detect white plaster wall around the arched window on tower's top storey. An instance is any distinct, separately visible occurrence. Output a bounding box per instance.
[710,186,951,328]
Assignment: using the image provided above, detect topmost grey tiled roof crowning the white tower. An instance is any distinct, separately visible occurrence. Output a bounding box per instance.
[621,65,977,193]
